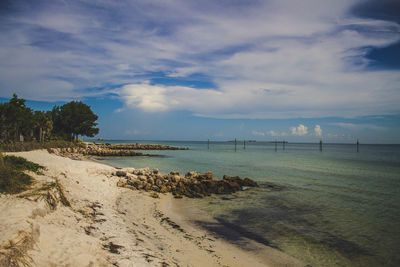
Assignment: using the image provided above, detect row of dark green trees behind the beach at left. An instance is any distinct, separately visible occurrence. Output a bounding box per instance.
[0,94,99,142]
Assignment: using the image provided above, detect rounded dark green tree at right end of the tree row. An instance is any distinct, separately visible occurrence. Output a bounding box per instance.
[50,101,99,140]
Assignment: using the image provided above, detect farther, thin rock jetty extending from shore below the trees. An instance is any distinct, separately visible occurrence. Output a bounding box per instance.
[48,143,186,158]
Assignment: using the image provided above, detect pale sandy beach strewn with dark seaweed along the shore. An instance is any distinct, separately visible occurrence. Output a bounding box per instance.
[0,150,304,266]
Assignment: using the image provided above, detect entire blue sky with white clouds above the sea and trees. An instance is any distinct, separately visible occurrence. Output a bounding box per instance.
[0,0,400,143]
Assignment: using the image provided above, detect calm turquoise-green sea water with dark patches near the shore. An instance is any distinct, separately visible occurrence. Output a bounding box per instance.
[99,141,400,266]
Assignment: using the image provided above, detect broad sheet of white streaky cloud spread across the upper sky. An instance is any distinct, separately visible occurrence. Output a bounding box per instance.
[0,0,400,118]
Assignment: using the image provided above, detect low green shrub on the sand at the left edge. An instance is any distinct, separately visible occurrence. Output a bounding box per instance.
[0,154,44,194]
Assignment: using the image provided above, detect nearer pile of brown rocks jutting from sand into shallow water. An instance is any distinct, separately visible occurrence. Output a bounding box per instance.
[113,168,258,198]
